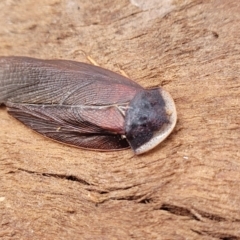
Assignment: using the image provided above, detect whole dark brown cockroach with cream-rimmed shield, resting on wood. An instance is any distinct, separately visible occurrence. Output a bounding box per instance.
[0,57,177,154]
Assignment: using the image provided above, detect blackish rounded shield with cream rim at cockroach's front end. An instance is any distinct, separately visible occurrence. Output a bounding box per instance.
[125,88,177,154]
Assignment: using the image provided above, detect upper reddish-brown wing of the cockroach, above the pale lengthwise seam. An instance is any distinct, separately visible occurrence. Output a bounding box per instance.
[0,57,142,106]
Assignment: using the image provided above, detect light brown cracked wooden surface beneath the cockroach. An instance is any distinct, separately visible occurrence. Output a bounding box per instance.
[0,0,240,240]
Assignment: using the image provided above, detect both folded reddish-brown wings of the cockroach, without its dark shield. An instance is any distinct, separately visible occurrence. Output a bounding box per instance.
[0,57,143,150]
